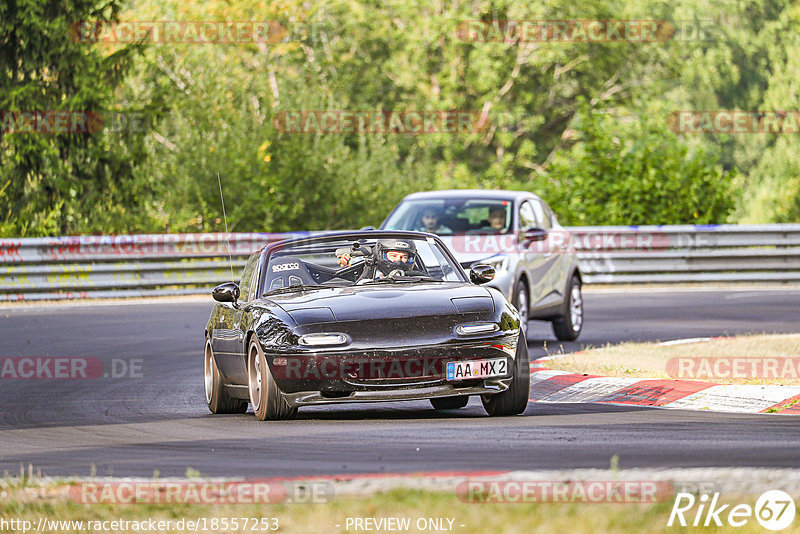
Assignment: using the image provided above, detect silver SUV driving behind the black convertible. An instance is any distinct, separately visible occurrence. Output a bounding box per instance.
[380,189,583,341]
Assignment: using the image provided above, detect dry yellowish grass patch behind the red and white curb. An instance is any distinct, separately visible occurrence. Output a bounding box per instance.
[544,334,800,385]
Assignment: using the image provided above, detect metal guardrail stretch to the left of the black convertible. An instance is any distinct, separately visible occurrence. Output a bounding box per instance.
[0,232,309,301]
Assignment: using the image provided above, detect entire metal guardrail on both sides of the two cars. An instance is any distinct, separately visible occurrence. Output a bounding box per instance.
[0,224,800,301]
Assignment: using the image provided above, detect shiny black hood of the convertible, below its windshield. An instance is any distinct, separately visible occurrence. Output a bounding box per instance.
[268,283,494,324]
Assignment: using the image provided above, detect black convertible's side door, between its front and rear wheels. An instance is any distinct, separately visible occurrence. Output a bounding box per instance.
[211,253,260,382]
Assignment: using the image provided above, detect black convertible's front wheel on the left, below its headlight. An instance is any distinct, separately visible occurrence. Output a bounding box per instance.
[247,336,297,421]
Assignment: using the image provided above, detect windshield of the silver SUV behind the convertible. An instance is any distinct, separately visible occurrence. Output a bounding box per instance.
[384,198,513,235]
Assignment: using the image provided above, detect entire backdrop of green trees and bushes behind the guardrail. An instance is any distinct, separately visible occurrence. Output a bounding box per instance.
[6,0,784,235]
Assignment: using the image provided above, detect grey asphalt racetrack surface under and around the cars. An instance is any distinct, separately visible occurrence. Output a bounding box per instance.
[0,290,800,477]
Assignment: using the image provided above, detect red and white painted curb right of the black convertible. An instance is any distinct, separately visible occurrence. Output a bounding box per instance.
[530,370,800,415]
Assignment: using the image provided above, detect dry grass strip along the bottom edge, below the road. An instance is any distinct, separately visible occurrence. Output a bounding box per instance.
[0,485,780,534]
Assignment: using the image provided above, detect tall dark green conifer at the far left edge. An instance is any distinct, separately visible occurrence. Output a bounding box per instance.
[0,0,152,236]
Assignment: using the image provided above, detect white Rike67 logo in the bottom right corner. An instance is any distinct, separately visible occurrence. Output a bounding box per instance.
[667,490,795,531]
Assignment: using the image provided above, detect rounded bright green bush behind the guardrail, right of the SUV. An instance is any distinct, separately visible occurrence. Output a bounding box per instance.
[525,106,736,225]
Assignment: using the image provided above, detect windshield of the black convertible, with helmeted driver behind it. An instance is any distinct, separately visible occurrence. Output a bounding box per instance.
[261,232,467,294]
